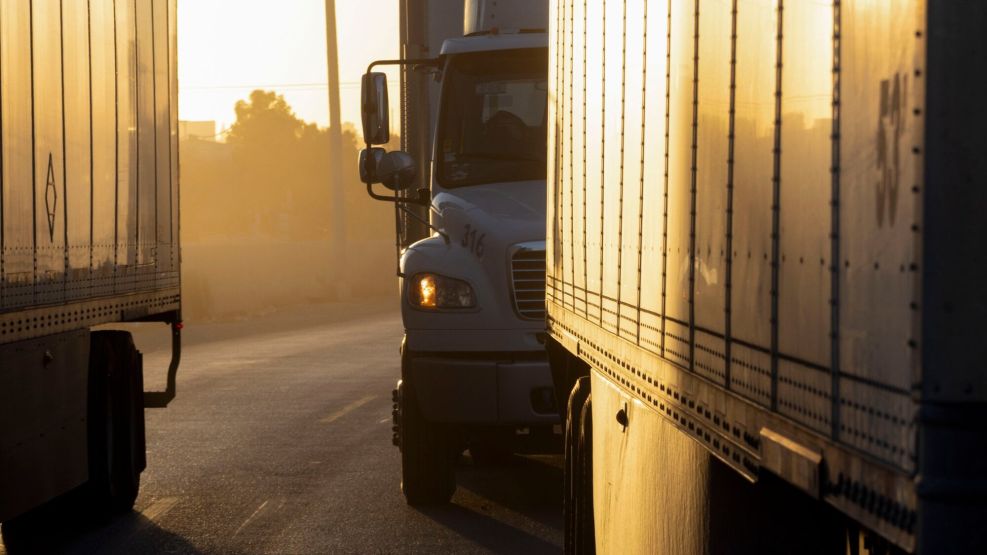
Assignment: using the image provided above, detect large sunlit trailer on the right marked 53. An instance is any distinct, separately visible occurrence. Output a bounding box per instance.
[546,0,987,553]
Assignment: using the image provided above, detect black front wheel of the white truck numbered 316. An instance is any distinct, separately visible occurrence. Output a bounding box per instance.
[397,381,456,506]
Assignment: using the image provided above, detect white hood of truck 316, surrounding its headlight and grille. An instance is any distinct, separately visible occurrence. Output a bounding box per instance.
[401,181,546,344]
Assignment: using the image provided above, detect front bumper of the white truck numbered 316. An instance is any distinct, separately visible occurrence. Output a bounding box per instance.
[405,353,559,426]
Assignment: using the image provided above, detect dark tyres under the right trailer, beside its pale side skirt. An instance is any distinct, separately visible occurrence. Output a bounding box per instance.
[562,377,596,554]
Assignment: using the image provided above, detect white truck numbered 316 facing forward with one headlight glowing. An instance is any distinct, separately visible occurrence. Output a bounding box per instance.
[360,0,560,504]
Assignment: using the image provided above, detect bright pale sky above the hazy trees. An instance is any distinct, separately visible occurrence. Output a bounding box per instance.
[178,0,400,135]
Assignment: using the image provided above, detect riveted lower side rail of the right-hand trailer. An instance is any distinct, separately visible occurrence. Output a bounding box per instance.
[548,301,917,551]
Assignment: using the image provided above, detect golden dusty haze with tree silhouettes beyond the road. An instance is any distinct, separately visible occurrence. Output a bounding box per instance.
[180,90,397,321]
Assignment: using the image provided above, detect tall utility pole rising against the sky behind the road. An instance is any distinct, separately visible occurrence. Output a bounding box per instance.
[325,0,349,297]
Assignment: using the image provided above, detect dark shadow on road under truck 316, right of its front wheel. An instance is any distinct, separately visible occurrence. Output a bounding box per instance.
[419,456,562,553]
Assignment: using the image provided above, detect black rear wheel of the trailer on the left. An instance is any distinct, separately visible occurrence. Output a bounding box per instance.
[86,331,146,514]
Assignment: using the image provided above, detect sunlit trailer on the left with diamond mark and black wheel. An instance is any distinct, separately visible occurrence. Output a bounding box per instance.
[0,0,181,522]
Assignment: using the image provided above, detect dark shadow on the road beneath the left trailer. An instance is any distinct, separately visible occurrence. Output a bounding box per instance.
[0,492,199,555]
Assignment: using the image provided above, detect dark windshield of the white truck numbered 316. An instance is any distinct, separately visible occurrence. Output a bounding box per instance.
[436,49,548,187]
